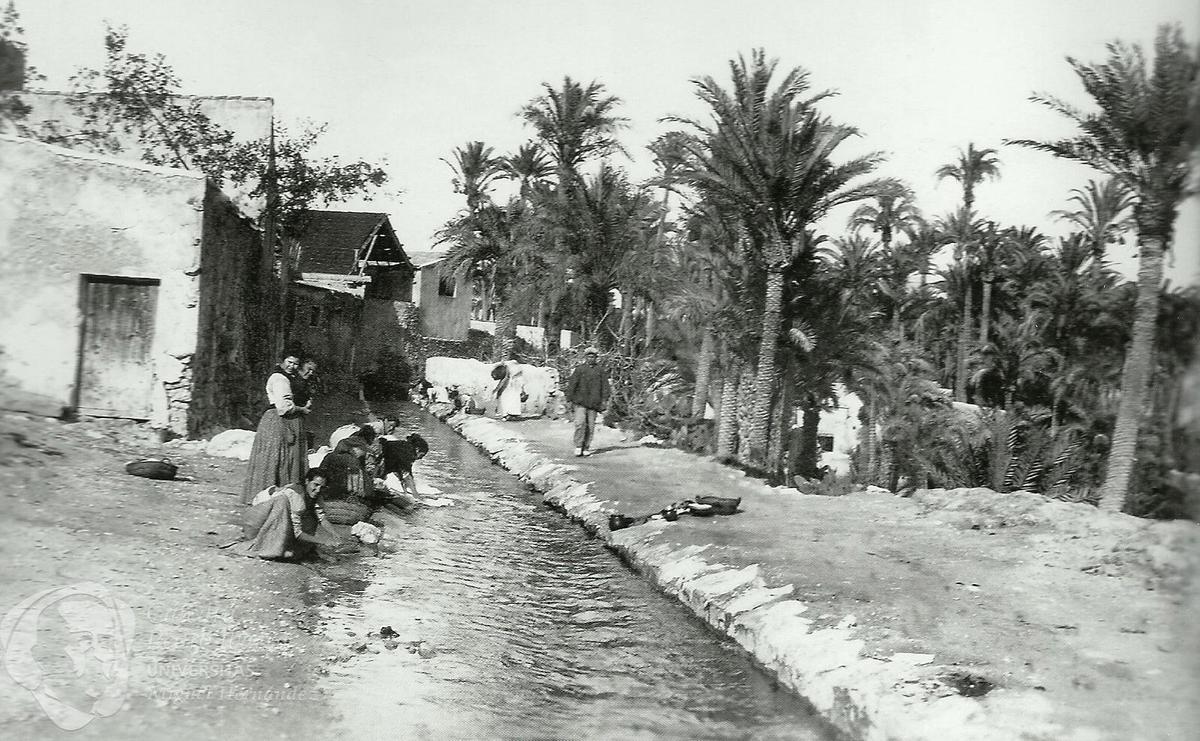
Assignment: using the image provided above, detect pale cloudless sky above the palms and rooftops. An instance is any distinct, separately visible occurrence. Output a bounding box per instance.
[17,0,1200,285]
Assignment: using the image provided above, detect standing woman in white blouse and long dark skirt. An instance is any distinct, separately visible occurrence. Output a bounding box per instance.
[241,354,311,505]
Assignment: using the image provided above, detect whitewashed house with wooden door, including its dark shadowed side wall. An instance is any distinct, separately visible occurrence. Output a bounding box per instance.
[0,135,277,435]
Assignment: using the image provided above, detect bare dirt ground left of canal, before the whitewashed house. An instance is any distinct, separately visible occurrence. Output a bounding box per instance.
[0,415,348,739]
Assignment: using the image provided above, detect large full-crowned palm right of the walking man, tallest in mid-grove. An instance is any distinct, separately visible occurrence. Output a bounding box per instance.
[672,49,881,465]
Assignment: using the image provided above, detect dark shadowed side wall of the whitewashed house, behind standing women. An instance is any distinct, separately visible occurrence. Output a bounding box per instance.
[189,183,278,436]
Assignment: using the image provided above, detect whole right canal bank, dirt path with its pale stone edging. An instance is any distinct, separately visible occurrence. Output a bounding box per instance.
[438,402,1200,740]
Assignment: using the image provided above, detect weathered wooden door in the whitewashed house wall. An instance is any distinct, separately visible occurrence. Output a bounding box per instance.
[76,276,158,420]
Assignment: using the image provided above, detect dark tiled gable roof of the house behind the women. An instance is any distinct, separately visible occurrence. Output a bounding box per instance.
[299,211,404,275]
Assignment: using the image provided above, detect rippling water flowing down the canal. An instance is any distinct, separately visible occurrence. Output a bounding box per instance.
[312,405,833,740]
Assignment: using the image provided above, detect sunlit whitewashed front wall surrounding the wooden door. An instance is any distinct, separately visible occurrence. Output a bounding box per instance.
[0,135,205,433]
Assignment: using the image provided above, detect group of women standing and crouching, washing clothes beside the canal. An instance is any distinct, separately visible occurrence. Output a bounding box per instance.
[238,354,428,559]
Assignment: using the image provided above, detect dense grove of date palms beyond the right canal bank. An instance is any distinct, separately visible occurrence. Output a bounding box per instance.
[439,26,1200,517]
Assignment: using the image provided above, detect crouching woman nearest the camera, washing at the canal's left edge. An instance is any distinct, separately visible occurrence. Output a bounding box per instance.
[234,469,336,560]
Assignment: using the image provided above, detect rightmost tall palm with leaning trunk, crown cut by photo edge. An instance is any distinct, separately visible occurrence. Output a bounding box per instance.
[1014,25,1200,511]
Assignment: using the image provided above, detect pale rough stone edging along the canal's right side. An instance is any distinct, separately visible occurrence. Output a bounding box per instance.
[431,410,1096,741]
